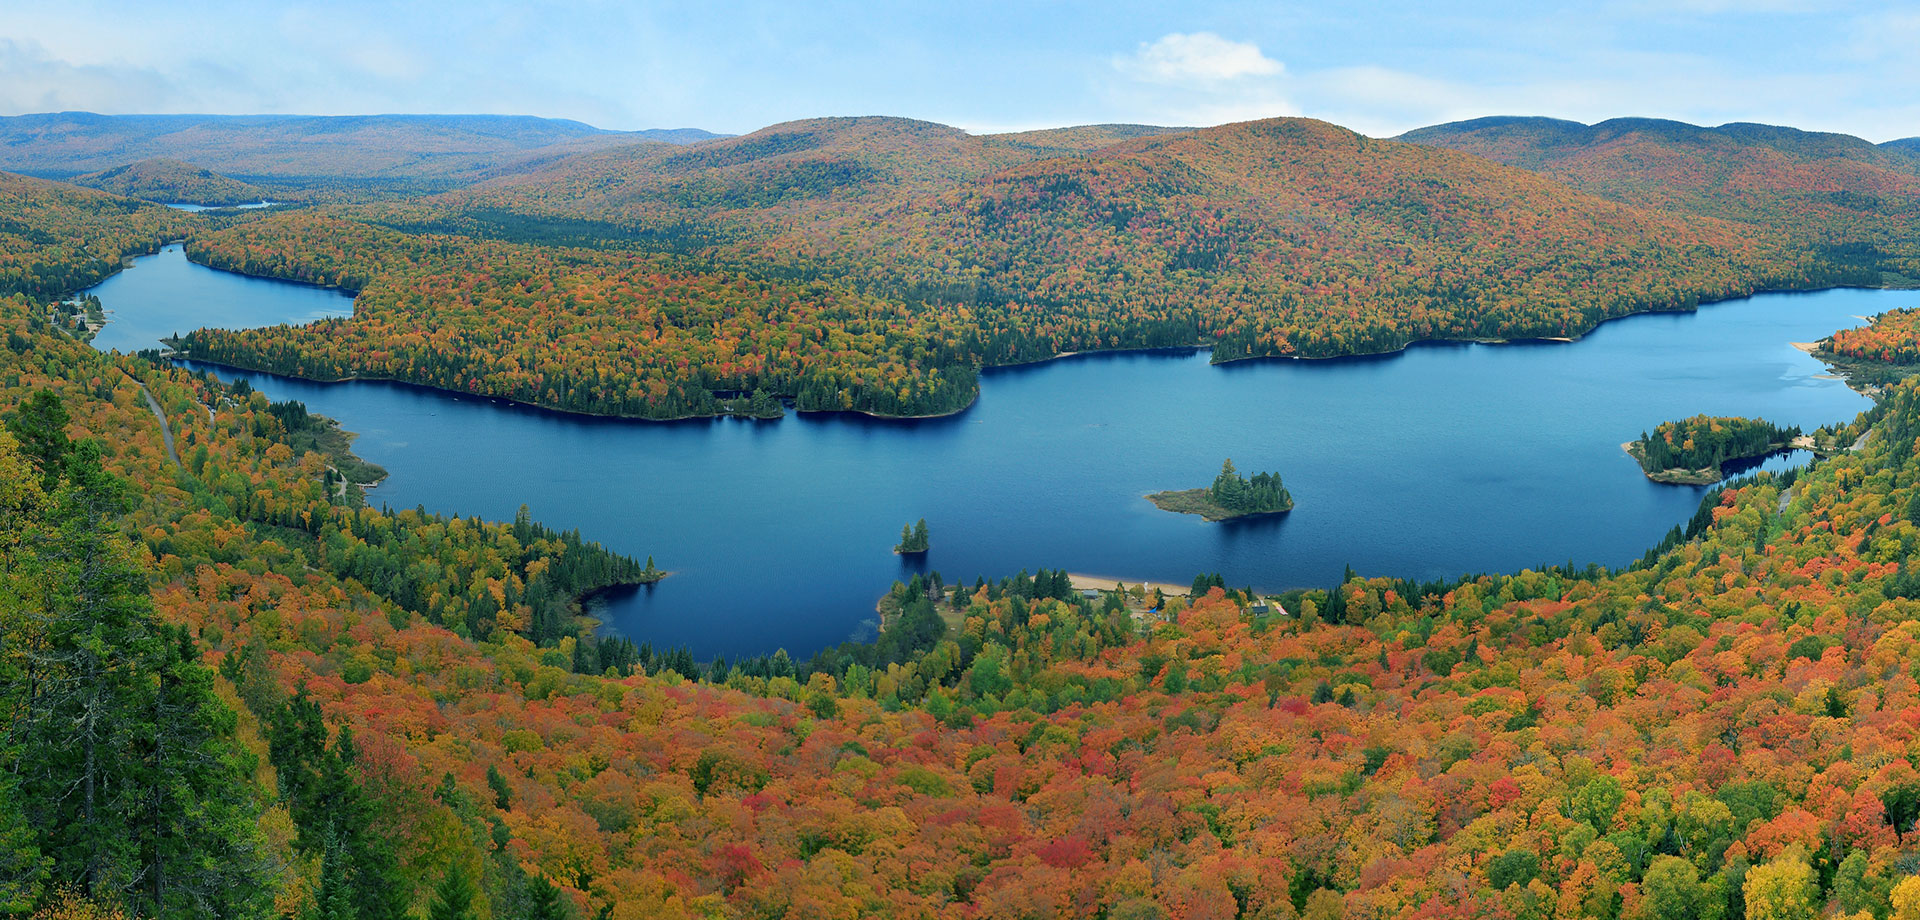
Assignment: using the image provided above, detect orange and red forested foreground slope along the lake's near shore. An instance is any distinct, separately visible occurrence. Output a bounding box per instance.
[18,214,1920,918]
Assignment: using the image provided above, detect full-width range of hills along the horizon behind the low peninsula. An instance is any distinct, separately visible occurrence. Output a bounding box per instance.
[0,113,1920,330]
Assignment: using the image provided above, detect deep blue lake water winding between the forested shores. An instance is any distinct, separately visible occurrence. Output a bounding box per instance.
[94,248,1889,657]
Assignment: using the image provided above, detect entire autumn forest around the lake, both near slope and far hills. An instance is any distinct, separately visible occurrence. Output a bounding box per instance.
[0,91,1920,920]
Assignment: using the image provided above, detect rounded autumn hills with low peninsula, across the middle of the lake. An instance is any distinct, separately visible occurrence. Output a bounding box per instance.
[161,119,1847,419]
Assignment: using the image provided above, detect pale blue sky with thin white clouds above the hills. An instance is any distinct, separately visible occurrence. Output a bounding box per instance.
[0,0,1920,142]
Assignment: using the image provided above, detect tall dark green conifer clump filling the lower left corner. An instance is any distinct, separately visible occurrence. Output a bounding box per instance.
[0,428,269,918]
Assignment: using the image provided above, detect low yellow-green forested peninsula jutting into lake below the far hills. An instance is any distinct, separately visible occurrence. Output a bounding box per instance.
[179,213,981,419]
